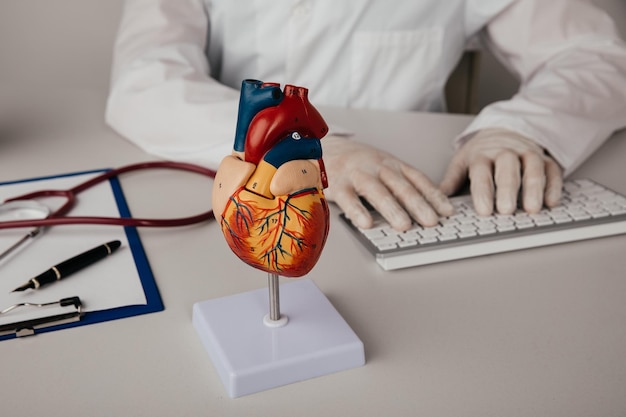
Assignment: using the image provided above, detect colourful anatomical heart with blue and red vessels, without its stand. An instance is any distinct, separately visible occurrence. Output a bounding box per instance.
[213,80,329,277]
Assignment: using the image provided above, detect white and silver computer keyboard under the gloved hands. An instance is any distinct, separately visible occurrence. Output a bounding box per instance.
[340,179,626,270]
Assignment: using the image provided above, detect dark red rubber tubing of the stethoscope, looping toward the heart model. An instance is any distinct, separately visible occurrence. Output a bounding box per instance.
[0,161,215,229]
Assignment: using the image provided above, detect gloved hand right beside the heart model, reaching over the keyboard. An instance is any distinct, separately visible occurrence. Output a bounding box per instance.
[322,136,454,231]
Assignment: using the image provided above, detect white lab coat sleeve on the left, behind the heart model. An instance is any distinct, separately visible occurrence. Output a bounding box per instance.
[105,0,239,169]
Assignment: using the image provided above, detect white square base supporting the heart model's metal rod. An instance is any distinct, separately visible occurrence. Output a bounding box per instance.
[193,279,365,397]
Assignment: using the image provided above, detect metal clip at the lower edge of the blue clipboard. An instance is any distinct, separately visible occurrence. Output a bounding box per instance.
[0,297,83,337]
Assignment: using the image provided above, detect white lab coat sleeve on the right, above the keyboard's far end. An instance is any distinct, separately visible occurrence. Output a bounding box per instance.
[456,0,626,175]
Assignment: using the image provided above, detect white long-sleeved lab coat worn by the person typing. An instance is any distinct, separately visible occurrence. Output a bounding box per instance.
[106,0,626,172]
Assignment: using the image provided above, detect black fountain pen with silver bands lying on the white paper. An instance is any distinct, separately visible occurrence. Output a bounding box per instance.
[12,240,121,292]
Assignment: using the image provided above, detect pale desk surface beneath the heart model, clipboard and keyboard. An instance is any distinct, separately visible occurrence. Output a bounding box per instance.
[0,85,626,417]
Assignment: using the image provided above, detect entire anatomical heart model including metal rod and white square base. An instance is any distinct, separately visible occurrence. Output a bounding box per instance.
[200,91,365,397]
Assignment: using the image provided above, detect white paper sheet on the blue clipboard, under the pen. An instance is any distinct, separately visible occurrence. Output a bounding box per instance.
[0,174,147,324]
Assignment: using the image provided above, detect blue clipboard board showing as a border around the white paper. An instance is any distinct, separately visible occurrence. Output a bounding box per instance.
[0,169,164,341]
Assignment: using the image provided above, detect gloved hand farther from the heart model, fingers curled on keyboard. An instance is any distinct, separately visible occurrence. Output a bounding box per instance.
[440,129,563,216]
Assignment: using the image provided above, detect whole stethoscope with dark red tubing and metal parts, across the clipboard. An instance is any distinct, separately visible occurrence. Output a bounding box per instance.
[0,161,215,260]
